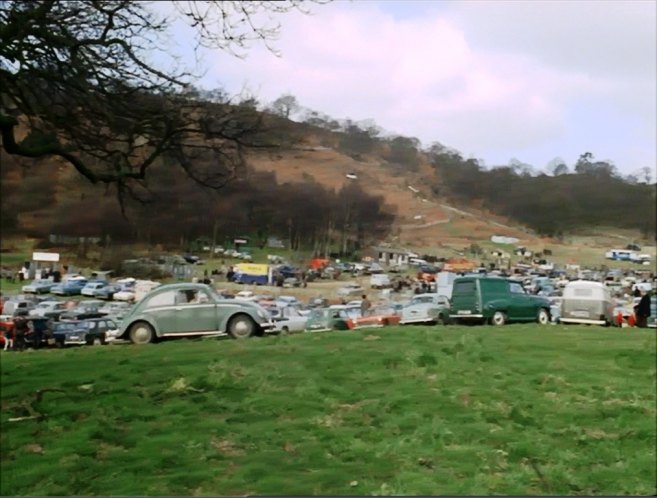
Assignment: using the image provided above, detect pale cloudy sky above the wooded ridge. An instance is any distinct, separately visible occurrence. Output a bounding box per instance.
[156,0,657,179]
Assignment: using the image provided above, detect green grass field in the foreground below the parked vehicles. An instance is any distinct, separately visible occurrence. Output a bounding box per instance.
[0,325,656,495]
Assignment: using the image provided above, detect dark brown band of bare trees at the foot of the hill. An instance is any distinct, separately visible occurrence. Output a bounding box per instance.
[0,149,394,255]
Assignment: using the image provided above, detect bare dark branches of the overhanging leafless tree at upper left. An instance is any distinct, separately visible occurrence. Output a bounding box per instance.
[0,0,323,208]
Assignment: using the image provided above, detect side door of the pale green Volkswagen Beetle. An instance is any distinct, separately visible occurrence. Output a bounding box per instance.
[176,289,219,334]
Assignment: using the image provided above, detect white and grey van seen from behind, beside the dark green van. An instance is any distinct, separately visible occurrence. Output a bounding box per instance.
[559,280,614,326]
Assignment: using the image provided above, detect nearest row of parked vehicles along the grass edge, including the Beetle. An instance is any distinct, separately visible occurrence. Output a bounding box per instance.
[5,275,657,344]
